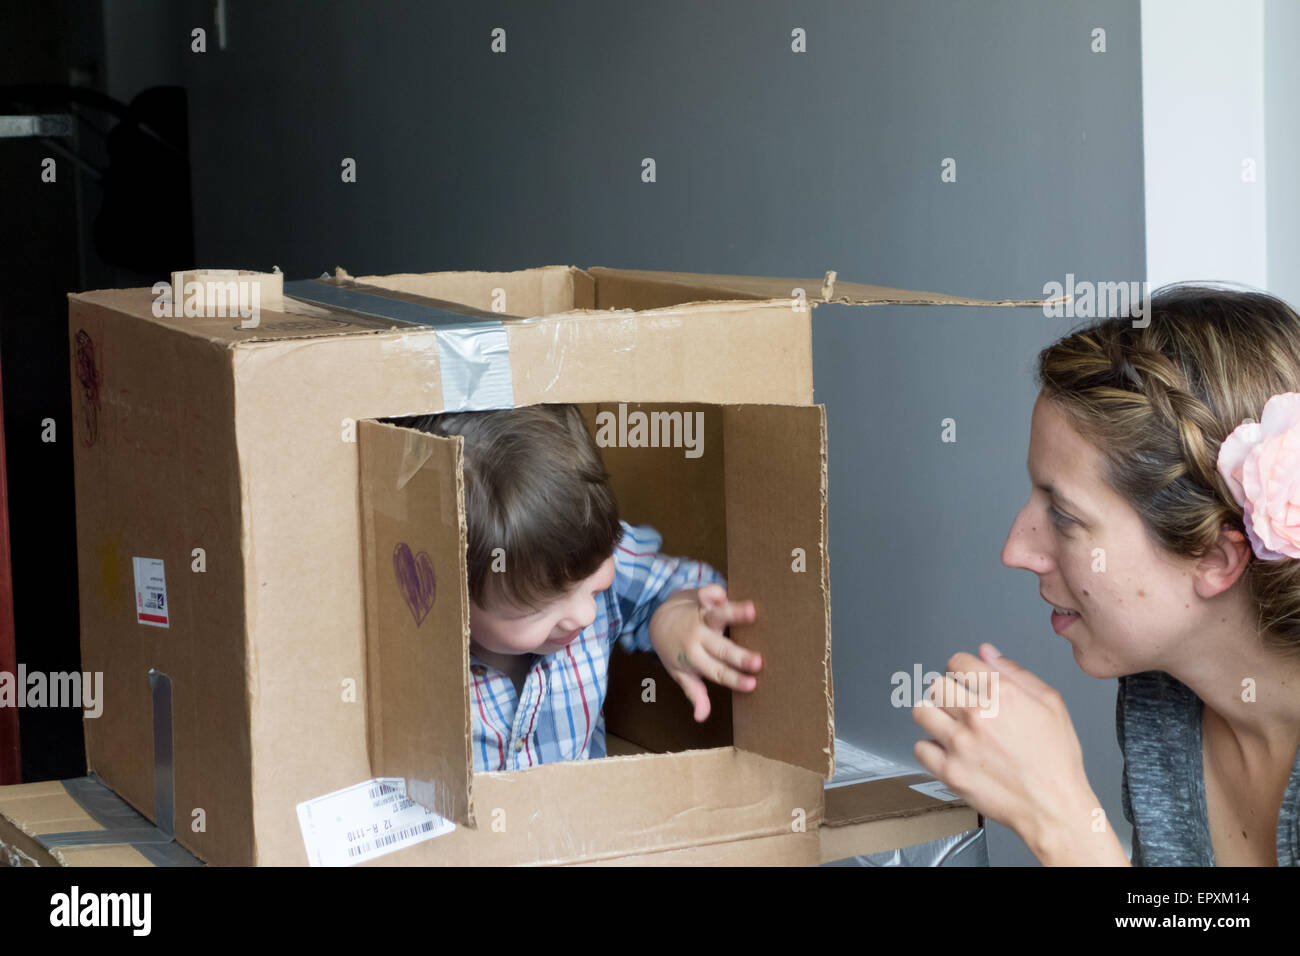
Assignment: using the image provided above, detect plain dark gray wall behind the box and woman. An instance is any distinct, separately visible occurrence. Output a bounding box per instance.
[105,0,1144,865]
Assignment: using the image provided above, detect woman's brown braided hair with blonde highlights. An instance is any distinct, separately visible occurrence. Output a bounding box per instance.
[1035,284,1300,653]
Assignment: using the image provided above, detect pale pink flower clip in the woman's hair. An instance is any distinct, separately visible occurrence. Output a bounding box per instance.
[1218,392,1300,561]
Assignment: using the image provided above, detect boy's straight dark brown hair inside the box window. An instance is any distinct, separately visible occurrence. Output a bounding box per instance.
[408,405,623,610]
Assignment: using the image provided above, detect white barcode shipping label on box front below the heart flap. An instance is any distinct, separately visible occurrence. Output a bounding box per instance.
[298,777,456,866]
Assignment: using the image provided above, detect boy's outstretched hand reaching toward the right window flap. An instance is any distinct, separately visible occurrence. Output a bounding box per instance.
[650,584,763,723]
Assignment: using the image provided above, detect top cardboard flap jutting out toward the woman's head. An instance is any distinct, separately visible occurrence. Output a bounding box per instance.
[586,265,1067,308]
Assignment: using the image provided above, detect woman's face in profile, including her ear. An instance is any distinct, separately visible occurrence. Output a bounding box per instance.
[1002,394,1244,678]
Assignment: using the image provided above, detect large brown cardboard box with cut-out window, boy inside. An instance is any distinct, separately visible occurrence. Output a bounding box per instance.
[69,267,1039,865]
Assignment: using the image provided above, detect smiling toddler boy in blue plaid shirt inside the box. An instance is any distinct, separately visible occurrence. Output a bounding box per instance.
[412,405,762,771]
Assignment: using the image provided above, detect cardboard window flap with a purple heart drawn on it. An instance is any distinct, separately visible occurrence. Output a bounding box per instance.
[356,420,475,826]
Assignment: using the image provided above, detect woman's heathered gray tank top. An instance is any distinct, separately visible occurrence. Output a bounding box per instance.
[1115,671,1300,866]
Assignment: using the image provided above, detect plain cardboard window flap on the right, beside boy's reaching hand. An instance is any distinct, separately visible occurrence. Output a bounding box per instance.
[723,405,835,779]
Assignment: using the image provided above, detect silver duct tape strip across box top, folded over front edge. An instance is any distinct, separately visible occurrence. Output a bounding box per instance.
[285,278,515,411]
